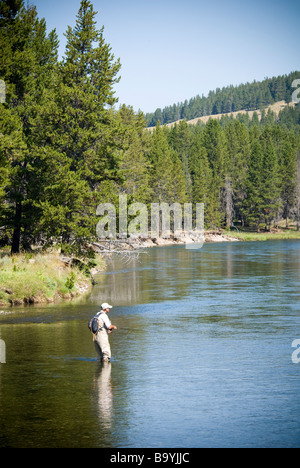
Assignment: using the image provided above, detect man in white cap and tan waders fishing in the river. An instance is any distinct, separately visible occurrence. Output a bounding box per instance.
[93,302,117,362]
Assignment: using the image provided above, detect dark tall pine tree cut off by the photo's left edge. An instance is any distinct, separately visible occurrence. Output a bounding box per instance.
[0,1,57,253]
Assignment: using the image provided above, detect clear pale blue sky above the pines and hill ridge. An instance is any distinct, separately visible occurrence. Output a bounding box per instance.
[30,0,300,112]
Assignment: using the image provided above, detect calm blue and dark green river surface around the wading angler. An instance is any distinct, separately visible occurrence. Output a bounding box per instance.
[0,241,300,448]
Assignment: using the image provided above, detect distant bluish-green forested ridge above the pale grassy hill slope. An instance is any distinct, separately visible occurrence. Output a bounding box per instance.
[146,71,300,127]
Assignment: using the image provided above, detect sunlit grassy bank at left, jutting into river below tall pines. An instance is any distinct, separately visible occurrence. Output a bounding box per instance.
[0,251,103,306]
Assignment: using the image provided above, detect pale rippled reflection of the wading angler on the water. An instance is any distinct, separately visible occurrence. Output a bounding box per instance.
[94,362,113,429]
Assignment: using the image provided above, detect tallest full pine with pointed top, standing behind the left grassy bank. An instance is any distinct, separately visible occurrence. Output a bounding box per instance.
[32,0,121,254]
